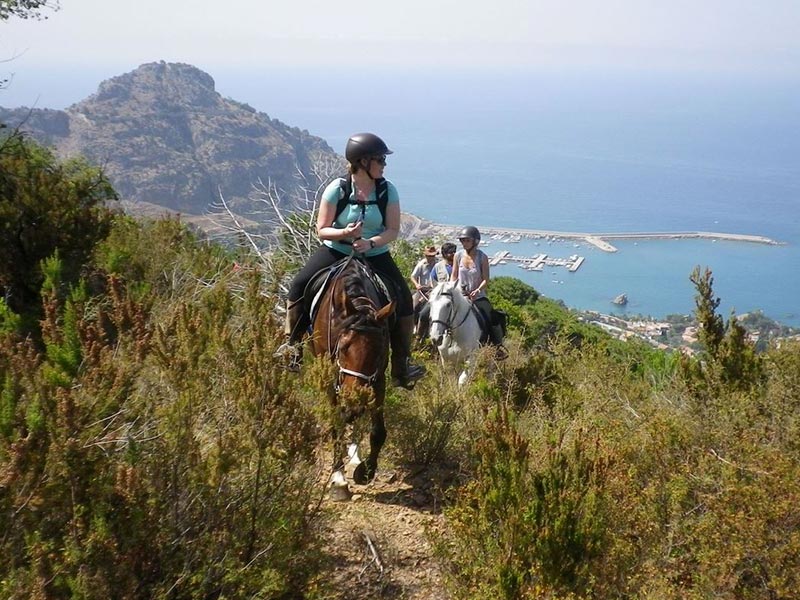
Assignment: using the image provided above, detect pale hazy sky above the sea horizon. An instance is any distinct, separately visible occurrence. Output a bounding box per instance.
[0,0,800,73]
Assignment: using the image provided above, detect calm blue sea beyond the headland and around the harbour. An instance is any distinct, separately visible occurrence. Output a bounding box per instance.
[7,67,800,326]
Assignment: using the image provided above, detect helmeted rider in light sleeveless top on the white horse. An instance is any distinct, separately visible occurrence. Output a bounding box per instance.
[450,225,503,345]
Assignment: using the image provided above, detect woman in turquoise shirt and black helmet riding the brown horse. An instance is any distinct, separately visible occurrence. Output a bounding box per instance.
[276,133,425,388]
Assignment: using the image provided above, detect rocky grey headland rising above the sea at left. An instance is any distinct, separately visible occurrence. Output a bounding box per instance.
[0,62,343,214]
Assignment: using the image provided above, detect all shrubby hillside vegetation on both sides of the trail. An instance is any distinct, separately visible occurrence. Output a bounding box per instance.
[0,138,800,599]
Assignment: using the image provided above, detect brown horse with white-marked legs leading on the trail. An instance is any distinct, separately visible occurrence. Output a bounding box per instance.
[313,257,394,492]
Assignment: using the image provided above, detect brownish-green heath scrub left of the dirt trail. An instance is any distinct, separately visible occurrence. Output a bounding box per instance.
[0,221,322,598]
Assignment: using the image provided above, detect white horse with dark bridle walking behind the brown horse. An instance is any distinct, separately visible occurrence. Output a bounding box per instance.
[428,281,481,385]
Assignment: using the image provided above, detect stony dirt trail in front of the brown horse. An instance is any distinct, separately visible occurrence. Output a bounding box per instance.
[324,468,452,600]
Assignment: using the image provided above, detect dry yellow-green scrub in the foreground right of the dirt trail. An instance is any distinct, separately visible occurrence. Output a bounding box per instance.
[438,330,800,599]
